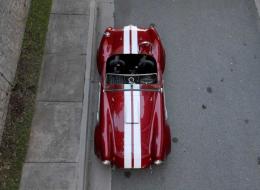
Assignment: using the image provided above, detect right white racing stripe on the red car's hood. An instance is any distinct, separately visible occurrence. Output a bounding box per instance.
[133,85,142,168]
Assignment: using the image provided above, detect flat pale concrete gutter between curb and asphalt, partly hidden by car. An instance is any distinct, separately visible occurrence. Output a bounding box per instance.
[86,0,114,190]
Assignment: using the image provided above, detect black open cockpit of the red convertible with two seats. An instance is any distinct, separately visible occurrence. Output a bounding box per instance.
[106,54,157,84]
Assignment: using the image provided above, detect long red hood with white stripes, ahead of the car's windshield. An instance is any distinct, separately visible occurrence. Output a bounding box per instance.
[106,85,160,168]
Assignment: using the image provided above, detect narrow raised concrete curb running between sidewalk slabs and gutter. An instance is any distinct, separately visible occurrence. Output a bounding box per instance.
[77,0,97,190]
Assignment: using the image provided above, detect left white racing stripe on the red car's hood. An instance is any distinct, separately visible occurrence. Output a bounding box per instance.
[124,84,132,168]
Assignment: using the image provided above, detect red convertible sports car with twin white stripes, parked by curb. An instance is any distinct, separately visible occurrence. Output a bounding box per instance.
[95,25,171,169]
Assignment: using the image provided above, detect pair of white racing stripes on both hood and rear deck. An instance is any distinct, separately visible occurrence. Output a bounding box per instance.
[123,26,142,168]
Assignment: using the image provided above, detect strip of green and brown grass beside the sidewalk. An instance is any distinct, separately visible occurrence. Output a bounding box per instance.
[0,0,52,190]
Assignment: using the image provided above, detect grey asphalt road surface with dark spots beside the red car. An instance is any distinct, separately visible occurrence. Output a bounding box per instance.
[112,0,260,190]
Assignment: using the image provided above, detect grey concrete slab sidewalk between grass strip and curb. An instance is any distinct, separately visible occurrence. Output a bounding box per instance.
[20,0,90,190]
